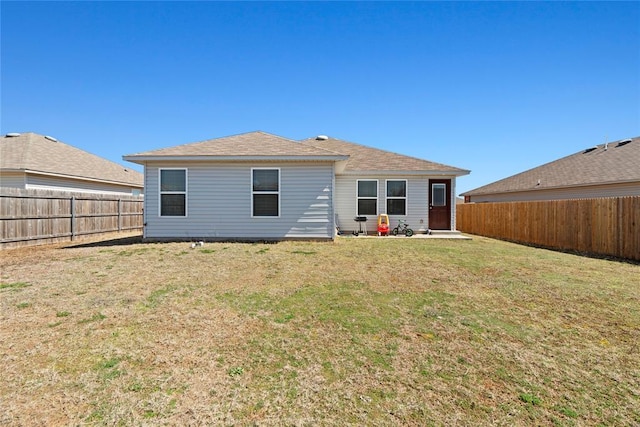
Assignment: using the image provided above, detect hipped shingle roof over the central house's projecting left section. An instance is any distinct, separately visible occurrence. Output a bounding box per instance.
[124,131,346,163]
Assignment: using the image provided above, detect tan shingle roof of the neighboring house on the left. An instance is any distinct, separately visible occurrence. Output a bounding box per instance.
[0,132,144,188]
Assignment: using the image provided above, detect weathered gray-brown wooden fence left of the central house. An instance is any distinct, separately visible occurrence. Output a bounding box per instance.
[0,188,143,248]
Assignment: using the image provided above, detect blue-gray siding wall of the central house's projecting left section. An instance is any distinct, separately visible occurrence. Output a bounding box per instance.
[145,162,334,240]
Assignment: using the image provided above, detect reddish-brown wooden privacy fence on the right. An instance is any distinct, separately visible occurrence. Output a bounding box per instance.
[456,196,640,261]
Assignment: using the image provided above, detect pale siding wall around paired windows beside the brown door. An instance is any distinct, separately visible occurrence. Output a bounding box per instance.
[335,175,440,233]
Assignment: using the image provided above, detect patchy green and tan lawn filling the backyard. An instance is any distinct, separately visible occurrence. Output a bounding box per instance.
[0,237,640,426]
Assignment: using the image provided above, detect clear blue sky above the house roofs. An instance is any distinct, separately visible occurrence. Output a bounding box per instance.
[0,1,640,193]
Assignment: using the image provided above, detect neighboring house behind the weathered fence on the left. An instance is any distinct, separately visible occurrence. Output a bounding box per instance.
[0,132,144,195]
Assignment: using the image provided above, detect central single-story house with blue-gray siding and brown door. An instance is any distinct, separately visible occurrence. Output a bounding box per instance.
[123,132,469,240]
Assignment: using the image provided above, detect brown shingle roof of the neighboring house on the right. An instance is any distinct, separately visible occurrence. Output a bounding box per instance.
[462,137,640,196]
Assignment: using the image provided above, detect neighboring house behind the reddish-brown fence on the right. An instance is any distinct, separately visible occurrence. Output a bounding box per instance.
[461,137,640,203]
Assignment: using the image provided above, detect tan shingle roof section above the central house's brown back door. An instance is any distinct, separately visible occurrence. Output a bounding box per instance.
[301,137,470,176]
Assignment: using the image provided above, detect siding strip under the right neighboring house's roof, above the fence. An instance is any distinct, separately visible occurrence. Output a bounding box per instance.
[470,182,640,203]
